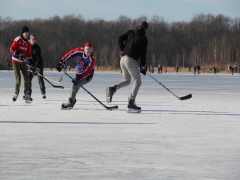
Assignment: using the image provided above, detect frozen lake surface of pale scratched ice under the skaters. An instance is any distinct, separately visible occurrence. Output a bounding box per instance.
[0,71,240,180]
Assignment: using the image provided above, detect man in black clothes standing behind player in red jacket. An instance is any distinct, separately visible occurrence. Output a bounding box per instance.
[28,34,46,99]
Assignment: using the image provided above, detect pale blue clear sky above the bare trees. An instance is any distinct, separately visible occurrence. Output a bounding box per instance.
[0,0,240,22]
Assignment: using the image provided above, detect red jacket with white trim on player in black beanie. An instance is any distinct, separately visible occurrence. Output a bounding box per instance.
[10,36,32,64]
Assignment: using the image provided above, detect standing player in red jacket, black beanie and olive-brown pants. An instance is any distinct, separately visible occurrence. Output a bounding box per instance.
[10,26,35,102]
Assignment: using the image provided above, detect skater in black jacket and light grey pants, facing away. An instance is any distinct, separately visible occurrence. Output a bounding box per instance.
[106,21,148,112]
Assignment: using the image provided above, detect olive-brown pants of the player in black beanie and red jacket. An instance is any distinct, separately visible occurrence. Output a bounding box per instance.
[12,62,29,92]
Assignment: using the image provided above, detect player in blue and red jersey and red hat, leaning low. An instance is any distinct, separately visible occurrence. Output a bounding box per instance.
[56,42,95,109]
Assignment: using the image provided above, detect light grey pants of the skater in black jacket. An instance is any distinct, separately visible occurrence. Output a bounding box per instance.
[116,56,142,99]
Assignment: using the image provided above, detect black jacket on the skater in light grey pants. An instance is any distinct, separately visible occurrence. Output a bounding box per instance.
[118,26,148,66]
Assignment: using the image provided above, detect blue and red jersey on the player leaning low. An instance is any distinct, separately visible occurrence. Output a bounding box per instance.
[61,47,95,78]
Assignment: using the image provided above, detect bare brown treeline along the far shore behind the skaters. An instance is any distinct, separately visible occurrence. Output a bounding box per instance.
[0,14,240,68]
